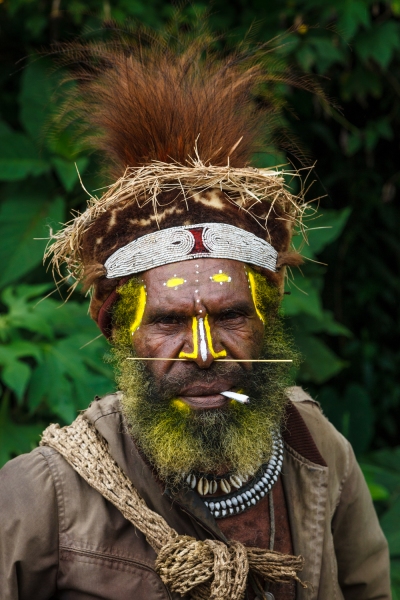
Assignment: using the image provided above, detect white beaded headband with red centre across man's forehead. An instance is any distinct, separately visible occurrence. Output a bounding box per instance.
[104,223,278,279]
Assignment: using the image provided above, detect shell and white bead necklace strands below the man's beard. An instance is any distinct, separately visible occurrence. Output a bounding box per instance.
[186,434,283,519]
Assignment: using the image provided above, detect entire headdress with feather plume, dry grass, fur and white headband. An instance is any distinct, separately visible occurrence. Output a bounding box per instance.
[46,23,310,334]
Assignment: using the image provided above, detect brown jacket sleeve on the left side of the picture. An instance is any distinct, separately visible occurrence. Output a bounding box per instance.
[0,449,58,600]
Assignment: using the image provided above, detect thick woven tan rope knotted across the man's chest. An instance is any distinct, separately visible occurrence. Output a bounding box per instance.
[40,415,307,600]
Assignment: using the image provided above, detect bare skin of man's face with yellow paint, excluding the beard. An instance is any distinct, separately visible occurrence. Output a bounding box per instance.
[132,258,264,409]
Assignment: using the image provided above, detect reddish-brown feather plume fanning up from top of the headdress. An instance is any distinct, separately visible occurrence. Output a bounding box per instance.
[54,23,322,178]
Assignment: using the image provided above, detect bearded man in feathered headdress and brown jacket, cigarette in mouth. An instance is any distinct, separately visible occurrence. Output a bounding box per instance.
[0,28,390,600]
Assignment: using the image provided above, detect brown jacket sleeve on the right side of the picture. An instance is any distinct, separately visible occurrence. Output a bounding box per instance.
[332,444,391,600]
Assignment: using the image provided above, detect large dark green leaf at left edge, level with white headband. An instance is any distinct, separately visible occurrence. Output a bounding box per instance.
[0,190,64,287]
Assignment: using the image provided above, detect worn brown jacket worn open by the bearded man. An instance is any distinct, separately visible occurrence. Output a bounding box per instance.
[0,388,391,600]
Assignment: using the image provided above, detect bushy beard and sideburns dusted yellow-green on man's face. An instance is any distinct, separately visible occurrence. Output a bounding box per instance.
[113,272,298,488]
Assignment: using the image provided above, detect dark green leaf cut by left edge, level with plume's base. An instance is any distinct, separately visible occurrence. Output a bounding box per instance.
[0,132,50,181]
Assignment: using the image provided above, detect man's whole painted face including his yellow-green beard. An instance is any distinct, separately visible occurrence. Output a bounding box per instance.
[113,258,295,486]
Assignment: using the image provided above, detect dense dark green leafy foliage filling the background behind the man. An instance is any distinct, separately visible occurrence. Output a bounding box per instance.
[0,0,400,598]
